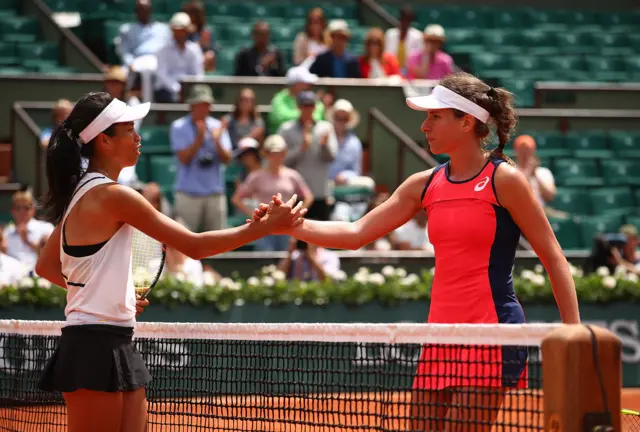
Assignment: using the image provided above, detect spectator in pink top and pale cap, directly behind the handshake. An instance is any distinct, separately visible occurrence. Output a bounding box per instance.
[231,135,313,252]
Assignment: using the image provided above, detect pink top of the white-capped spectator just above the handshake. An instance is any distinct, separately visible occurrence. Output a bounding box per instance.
[238,167,311,204]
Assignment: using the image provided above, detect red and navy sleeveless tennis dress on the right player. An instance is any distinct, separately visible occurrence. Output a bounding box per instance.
[413,158,527,390]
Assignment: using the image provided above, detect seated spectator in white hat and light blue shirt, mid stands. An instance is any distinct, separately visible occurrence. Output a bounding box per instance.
[327,99,375,189]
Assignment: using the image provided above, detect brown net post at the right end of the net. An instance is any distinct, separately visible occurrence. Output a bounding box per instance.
[542,325,622,432]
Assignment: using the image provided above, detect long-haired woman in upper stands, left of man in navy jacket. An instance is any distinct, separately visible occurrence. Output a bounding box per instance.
[293,8,329,66]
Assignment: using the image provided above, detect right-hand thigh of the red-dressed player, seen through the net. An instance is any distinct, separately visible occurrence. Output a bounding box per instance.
[444,387,504,432]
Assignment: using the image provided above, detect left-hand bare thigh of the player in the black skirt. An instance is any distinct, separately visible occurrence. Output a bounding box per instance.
[63,390,122,432]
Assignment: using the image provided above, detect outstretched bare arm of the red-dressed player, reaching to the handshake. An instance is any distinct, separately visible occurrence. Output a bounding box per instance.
[287,170,432,250]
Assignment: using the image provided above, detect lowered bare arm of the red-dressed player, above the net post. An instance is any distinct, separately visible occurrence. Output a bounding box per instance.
[495,164,580,324]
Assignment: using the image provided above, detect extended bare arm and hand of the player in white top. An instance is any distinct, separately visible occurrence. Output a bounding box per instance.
[101,184,306,259]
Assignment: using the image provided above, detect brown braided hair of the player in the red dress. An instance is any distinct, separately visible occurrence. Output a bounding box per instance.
[440,72,518,165]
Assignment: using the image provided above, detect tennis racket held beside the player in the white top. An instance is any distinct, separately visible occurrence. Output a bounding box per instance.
[131,229,166,299]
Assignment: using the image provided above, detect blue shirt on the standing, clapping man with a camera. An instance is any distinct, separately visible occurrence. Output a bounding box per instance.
[171,115,231,197]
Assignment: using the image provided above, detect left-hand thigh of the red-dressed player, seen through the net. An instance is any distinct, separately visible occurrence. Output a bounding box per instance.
[410,389,451,432]
